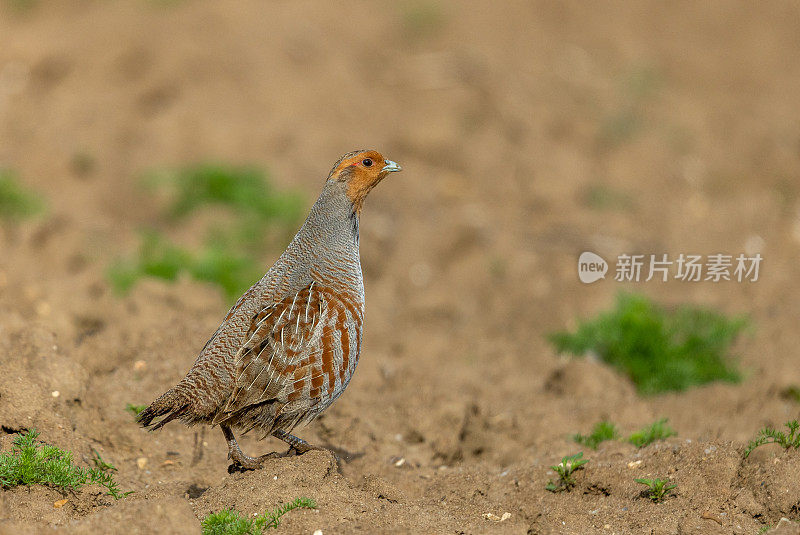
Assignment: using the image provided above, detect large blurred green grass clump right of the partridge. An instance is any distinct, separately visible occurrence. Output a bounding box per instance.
[548,293,747,394]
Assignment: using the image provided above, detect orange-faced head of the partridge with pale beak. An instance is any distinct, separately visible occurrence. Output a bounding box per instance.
[328,150,402,213]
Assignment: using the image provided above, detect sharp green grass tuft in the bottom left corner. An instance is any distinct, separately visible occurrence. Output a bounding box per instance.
[0,429,132,500]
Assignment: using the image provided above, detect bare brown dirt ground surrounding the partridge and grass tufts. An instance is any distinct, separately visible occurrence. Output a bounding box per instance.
[0,0,800,535]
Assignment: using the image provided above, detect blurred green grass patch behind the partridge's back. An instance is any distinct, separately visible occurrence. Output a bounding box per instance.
[108,164,303,299]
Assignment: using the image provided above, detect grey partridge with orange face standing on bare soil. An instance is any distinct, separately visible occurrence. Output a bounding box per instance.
[139,150,401,469]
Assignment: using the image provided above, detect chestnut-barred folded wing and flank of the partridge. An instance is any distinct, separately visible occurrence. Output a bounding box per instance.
[219,283,360,426]
